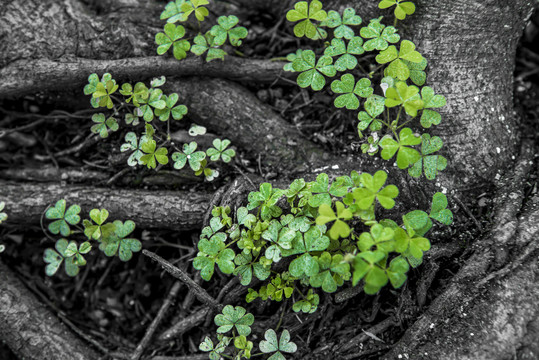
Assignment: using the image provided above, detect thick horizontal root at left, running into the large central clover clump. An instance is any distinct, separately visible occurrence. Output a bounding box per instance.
[0,181,210,230]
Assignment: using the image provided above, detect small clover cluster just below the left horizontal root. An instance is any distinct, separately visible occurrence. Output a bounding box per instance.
[43,199,142,276]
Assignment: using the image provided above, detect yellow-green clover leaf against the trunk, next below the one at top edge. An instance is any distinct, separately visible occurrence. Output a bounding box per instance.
[376,40,423,81]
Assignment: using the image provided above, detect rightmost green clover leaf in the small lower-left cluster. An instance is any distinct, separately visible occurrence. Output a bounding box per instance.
[99,220,142,261]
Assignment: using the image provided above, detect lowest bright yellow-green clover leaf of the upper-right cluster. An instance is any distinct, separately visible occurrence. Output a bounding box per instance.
[380,128,421,169]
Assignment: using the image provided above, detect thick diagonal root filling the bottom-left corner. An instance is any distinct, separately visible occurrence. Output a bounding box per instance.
[0,261,98,360]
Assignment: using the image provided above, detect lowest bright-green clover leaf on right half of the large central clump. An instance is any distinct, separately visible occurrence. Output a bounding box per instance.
[352,251,388,295]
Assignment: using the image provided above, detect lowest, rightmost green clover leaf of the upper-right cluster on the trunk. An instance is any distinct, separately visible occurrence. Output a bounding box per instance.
[408,134,447,180]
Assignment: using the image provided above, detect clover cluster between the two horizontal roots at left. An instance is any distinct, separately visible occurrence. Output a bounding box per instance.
[84,72,236,180]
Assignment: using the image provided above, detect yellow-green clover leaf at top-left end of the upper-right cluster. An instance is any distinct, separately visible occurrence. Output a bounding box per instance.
[286,0,328,40]
